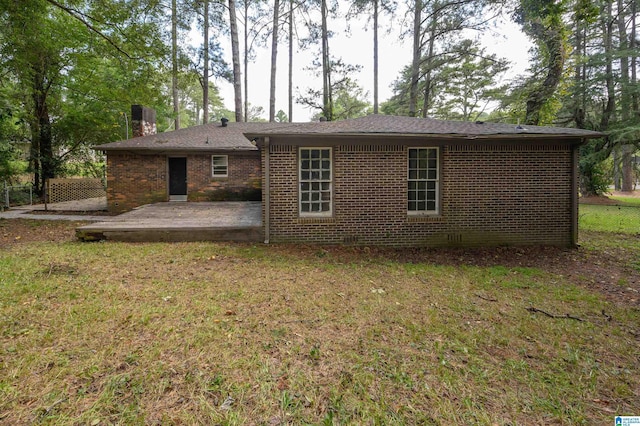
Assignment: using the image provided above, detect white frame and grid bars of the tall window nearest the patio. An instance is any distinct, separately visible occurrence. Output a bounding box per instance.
[298,147,333,217]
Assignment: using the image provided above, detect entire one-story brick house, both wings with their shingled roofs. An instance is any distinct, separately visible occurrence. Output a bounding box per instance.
[96,115,602,246]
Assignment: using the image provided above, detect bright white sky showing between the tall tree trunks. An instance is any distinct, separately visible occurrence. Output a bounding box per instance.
[209,5,531,122]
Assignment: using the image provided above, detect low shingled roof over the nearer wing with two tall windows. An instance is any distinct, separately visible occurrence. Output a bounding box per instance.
[247,115,604,139]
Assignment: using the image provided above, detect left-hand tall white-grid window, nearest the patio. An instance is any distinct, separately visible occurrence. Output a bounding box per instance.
[300,148,333,216]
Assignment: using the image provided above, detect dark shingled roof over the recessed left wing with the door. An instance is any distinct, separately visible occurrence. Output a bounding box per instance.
[93,122,291,151]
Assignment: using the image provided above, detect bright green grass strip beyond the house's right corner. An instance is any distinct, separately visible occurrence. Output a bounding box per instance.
[579,204,640,234]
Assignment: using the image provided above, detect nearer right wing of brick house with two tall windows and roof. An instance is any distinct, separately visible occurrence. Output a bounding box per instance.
[246,115,602,246]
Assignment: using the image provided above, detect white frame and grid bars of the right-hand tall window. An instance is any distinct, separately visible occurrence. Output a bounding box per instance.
[407,146,440,216]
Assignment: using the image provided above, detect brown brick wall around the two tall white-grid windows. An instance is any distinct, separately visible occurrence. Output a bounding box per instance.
[263,141,572,246]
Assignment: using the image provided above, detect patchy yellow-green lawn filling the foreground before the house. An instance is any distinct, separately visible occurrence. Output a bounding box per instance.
[0,233,640,425]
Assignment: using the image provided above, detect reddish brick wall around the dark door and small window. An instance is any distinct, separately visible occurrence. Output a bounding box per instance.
[107,151,260,212]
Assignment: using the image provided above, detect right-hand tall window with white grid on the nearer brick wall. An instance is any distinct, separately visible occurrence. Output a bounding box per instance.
[407,148,440,214]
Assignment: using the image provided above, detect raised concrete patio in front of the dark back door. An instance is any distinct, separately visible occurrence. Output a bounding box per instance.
[76,201,262,242]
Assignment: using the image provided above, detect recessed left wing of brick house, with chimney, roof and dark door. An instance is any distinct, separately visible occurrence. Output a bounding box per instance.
[94,110,290,213]
